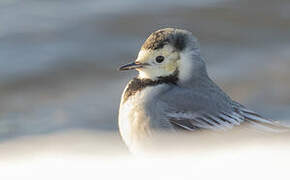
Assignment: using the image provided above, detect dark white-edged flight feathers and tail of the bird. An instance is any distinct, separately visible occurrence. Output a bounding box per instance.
[166,102,289,132]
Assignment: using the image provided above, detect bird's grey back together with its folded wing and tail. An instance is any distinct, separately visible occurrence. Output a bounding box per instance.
[155,68,282,131]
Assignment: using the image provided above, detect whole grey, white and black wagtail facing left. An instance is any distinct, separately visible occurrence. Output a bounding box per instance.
[119,28,286,151]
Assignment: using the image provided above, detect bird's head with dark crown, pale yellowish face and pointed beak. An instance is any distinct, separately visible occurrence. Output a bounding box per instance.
[120,28,205,80]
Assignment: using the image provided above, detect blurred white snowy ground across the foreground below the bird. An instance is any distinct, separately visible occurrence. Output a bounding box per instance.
[0,130,290,180]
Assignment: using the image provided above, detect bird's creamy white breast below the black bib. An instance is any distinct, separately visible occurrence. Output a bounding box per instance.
[119,85,162,152]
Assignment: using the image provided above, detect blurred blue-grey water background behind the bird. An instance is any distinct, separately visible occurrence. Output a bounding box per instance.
[0,0,290,155]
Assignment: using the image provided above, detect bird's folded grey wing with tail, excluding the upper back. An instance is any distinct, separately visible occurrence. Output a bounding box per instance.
[162,88,285,131]
